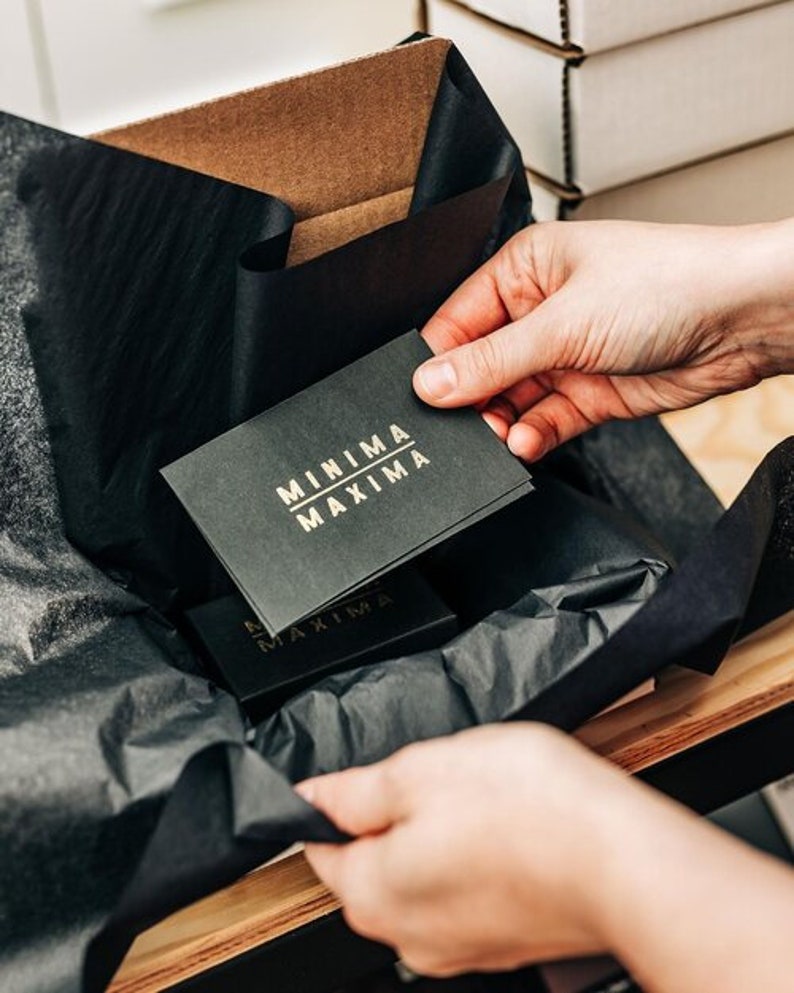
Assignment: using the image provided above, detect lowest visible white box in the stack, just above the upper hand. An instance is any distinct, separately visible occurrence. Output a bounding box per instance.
[530,136,794,224]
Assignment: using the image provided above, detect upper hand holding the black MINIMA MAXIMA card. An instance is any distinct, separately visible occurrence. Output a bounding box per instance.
[414,221,794,460]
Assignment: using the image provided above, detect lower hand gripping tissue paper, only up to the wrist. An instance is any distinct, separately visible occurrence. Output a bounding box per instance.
[298,724,625,975]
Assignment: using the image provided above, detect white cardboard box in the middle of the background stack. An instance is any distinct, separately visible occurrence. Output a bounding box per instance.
[428,0,794,194]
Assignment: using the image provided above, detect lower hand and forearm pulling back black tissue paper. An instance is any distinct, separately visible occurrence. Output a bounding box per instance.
[296,724,794,993]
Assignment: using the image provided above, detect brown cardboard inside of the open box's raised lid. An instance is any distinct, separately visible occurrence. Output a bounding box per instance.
[95,38,451,264]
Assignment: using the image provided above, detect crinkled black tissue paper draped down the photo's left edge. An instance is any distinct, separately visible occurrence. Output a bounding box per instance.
[0,108,249,993]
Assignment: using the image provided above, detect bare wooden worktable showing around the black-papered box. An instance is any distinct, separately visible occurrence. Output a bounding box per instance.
[110,377,794,993]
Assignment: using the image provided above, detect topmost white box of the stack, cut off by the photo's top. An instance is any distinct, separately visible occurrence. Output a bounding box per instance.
[448,0,779,53]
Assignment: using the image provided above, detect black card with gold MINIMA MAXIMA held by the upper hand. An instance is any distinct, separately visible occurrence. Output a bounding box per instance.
[163,331,531,633]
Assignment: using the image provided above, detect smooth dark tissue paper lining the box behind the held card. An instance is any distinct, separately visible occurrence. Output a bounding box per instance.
[20,43,529,609]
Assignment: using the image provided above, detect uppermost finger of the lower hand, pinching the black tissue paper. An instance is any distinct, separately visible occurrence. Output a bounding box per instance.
[295,762,402,837]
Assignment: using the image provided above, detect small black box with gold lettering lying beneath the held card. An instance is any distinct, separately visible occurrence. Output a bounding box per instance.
[185,566,458,721]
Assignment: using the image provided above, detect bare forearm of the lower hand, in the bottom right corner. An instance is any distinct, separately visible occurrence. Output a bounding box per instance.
[580,786,794,993]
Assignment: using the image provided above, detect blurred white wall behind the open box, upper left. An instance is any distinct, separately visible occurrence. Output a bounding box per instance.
[0,0,418,134]
